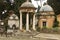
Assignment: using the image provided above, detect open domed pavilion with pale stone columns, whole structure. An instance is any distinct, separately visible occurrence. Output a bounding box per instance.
[19,0,36,31]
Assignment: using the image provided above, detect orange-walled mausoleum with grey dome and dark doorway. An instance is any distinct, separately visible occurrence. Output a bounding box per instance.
[38,4,55,28]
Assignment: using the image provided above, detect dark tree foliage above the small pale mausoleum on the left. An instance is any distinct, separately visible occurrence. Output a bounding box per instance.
[0,0,31,19]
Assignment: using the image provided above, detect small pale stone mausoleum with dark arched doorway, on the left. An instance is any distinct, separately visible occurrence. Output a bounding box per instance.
[8,10,19,28]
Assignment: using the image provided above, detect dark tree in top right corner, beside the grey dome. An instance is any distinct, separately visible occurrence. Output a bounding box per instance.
[47,0,60,15]
